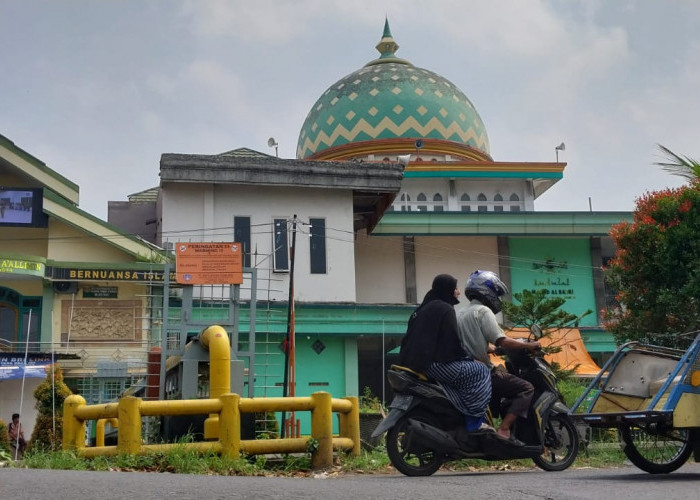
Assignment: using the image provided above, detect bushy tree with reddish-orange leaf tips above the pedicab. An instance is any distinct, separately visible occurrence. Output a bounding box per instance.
[605,180,700,348]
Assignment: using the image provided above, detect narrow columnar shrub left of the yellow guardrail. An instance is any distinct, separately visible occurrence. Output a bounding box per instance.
[27,364,72,451]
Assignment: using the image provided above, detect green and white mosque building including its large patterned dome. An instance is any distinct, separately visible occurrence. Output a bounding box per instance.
[124,22,631,432]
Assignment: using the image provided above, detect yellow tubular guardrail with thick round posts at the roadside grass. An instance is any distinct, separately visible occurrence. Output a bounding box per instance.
[63,392,360,469]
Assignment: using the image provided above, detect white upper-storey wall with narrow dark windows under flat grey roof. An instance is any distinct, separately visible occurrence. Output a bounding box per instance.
[162,184,355,302]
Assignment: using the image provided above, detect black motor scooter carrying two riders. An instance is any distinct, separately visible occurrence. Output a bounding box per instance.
[372,325,579,476]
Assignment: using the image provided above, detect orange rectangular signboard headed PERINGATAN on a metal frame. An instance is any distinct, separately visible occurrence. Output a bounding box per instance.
[175,242,243,285]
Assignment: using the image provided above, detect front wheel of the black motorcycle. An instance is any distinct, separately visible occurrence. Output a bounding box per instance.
[532,415,579,472]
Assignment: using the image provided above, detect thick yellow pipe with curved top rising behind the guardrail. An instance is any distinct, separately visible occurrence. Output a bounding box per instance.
[199,325,231,439]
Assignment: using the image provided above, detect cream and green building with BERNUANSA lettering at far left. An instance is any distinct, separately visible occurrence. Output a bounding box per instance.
[0,135,165,438]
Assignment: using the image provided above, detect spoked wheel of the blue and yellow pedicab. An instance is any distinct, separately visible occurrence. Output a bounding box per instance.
[620,425,693,474]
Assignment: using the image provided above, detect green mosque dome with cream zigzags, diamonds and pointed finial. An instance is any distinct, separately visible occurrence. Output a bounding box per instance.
[297,22,489,159]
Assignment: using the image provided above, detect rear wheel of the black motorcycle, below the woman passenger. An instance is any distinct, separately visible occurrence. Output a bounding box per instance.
[386,412,443,476]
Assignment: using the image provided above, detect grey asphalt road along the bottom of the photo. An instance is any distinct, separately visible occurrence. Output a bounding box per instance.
[0,463,700,500]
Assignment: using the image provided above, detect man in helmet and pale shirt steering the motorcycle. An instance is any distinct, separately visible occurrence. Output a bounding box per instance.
[457,271,540,438]
